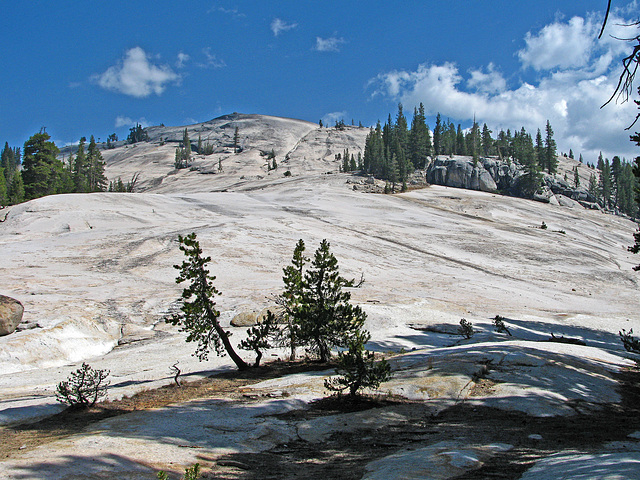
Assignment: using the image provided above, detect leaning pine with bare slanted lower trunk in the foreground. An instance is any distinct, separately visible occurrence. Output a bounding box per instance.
[166,233,248,370]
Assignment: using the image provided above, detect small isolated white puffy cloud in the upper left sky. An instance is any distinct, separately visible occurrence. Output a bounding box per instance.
[92,47,180,98]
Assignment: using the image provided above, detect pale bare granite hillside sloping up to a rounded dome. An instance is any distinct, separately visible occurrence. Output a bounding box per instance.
[0,114,640,478]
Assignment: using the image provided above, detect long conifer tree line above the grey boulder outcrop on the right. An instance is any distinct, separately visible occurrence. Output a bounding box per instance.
[362,103,638,212]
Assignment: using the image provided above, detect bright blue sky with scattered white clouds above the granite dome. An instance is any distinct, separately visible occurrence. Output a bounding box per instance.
[0,0,640,161]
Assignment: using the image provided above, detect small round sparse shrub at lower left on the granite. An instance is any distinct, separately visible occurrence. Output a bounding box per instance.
[56,363,109,408]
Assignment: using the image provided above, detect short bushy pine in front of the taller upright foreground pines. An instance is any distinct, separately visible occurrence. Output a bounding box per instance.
[324,331,391,398]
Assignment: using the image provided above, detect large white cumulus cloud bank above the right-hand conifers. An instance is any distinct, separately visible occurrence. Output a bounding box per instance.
[369,11,636,161]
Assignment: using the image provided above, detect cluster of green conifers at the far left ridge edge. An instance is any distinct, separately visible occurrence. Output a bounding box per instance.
[0,128,108,205]
